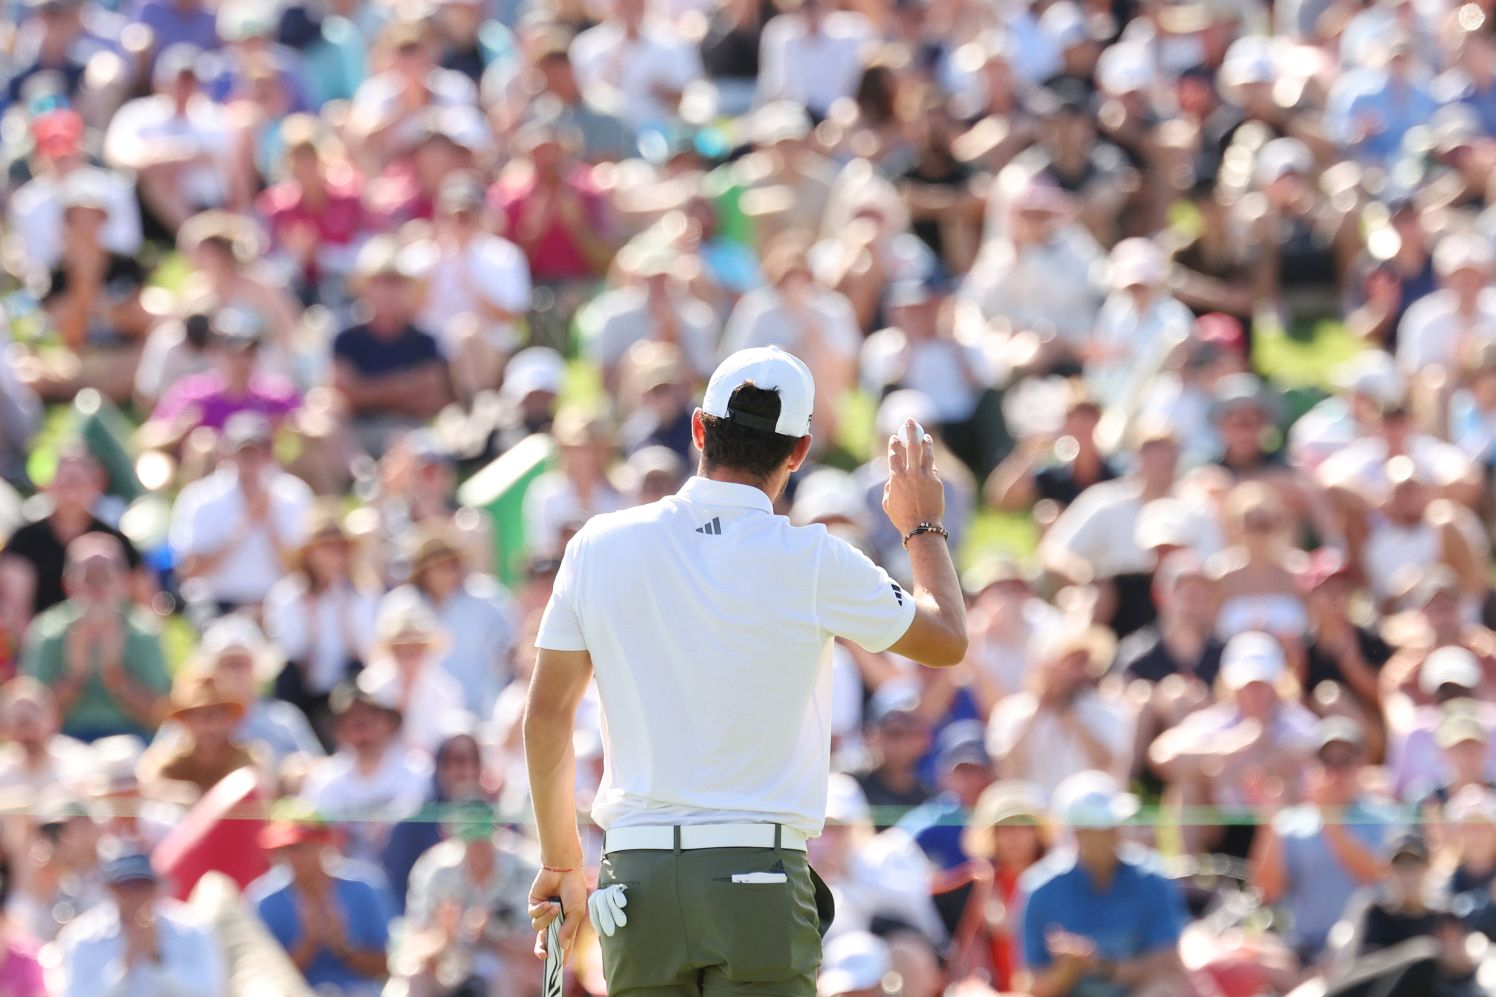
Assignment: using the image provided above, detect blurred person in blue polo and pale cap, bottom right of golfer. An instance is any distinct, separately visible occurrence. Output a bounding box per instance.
[1019,771,1189,997]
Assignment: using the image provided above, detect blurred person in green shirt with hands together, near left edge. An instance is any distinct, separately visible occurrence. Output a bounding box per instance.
[22,533,171,741]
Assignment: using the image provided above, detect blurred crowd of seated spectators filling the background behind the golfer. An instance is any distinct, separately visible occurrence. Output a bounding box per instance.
[0,0,1496,997]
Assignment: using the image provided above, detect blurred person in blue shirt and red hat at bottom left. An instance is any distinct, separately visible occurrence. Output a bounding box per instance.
[245,816,393,997]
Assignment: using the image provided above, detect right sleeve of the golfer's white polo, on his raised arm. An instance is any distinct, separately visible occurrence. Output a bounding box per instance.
[815,534,914,653]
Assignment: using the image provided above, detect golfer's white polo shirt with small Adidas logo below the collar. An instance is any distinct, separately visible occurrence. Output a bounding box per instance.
[536,478,914,835]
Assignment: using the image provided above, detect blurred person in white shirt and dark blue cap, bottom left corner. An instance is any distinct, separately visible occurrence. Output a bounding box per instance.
[55,852,229,997]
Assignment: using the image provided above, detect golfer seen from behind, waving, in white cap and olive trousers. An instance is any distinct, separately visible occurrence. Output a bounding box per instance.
[524,347,966,997]
